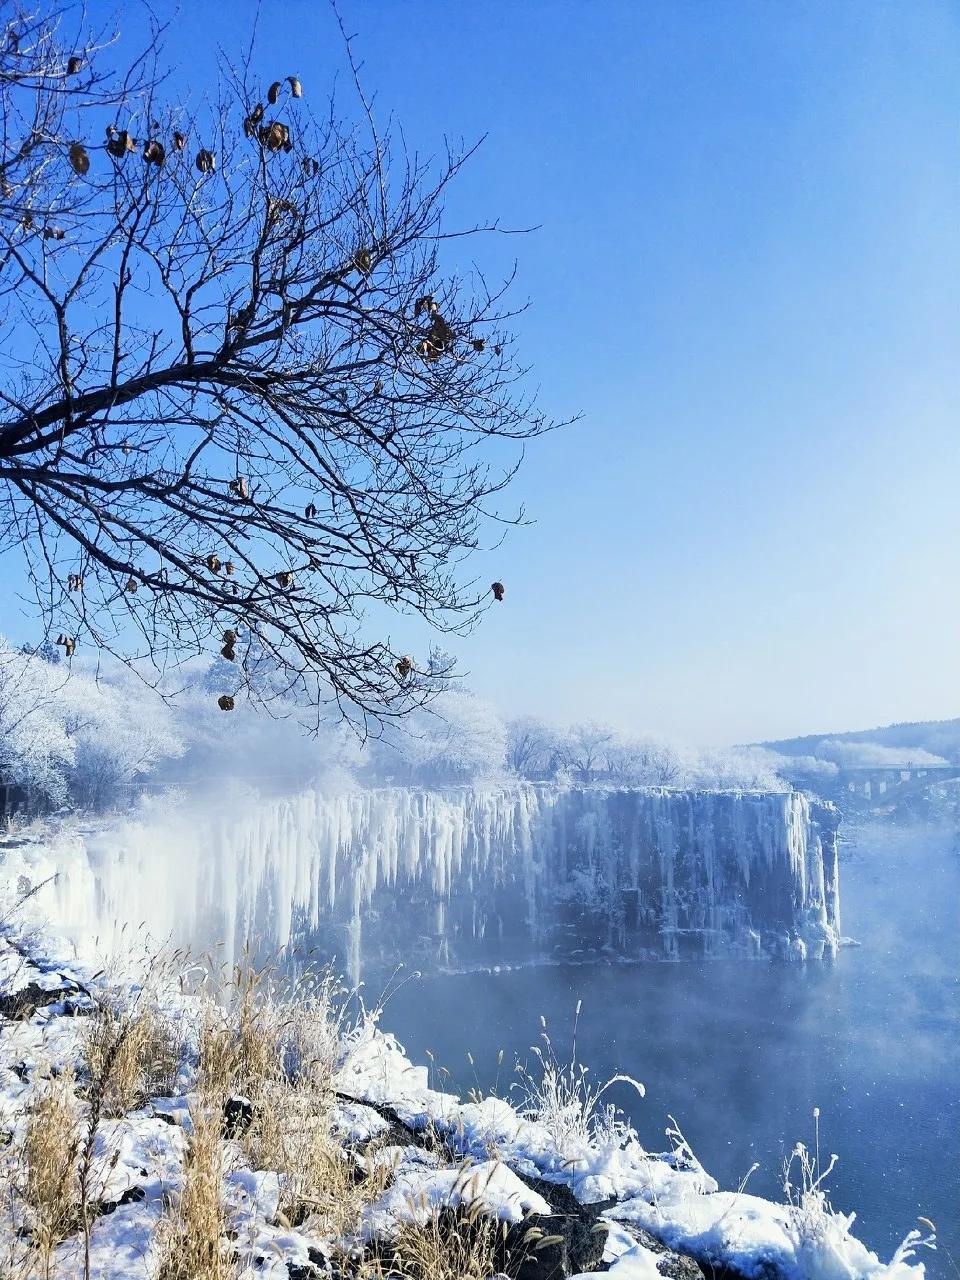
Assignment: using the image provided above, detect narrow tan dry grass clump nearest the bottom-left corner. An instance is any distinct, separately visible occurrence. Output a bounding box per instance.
[20,1073,81,1276]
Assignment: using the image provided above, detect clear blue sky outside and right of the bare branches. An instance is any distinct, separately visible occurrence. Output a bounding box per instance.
[0,0,960,742]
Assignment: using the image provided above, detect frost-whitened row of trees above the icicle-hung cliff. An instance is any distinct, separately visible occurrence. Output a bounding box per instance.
[0,641,783,809]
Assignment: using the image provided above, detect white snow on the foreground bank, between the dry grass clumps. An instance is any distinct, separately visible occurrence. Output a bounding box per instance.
[0,906,923,1280]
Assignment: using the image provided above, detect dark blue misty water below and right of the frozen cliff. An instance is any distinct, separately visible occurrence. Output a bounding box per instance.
[384,826,960,1280]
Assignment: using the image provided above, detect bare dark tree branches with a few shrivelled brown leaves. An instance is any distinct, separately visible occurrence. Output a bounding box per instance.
[0,9,563,727]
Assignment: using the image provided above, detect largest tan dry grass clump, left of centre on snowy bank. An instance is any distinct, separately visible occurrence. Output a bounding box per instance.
[159,963,363,1280]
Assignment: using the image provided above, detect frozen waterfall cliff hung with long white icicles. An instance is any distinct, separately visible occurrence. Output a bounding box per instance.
[13,783,840,974]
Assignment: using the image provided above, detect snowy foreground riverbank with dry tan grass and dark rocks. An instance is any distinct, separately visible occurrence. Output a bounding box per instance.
[0,901,923,1280]
